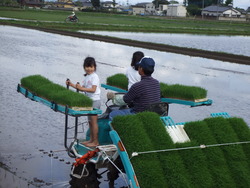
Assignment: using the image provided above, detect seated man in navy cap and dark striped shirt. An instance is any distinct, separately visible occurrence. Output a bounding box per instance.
[109,56,161,120]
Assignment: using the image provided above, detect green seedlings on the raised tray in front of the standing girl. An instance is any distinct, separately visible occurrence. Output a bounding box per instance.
[21,75,93,107]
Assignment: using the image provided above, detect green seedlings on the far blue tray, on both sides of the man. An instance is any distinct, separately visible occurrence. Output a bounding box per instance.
[106,74,207,101]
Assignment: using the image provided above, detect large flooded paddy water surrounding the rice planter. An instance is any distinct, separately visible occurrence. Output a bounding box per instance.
[0,26,250,187]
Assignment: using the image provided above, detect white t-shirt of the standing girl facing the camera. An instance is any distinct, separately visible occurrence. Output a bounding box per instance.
[83,72,101,101]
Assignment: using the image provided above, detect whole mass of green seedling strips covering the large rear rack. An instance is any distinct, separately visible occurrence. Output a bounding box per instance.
[112,112,250,188]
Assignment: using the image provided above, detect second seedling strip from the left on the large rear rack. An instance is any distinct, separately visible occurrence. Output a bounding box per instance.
[137,112,192,188]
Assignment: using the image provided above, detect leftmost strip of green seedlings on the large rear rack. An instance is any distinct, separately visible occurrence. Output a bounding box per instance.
[112,115,167,188]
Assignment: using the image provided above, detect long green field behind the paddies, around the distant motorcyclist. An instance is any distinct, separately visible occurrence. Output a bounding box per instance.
[0,7,250,36]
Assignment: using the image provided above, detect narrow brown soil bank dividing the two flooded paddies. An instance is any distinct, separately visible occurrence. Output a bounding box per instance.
[1,23,250,65]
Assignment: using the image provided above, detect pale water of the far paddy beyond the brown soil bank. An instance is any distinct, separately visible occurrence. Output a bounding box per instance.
[80,31,250,56]
